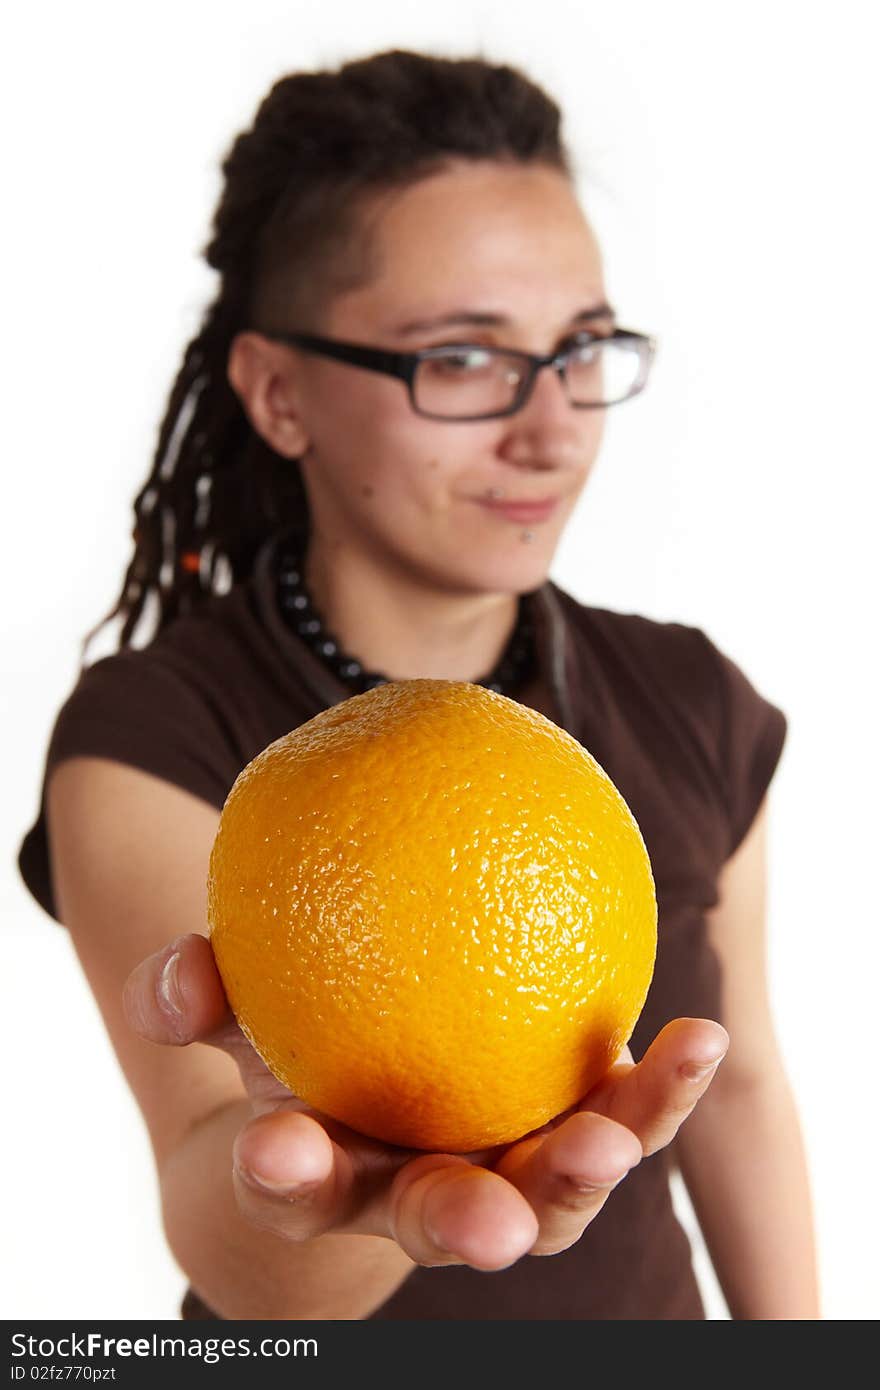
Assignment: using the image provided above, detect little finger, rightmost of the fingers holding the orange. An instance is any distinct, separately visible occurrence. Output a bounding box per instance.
[581,1019,730,1154]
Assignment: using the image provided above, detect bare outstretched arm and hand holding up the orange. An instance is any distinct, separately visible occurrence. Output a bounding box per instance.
[49,758,727,1319]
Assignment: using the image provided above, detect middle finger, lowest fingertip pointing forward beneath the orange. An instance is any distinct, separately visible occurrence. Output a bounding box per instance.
[386,1154,538,1270]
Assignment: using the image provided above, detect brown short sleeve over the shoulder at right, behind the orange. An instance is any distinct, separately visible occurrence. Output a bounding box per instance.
[699,632,788,858]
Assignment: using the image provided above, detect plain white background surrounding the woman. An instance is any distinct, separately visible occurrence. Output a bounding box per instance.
[0,0,880,1319]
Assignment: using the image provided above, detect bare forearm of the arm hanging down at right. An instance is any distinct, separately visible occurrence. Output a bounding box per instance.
[676,1070,819,1319]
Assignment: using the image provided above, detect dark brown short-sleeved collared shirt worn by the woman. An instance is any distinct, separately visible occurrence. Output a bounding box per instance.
[18,525,785,1319]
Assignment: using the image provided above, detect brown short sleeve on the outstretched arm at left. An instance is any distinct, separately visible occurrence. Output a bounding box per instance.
[18,649,242,922]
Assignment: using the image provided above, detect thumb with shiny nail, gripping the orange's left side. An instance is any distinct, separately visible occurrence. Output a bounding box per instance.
[122,933,236,1047]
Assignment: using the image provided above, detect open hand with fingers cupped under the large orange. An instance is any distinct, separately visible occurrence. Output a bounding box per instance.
[124,934,728,1269]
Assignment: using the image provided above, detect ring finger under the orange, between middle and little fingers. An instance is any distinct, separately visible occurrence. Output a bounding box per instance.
[495,1112,642,1255]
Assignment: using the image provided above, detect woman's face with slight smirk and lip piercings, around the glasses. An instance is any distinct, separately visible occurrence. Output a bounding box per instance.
[276,163,612,594]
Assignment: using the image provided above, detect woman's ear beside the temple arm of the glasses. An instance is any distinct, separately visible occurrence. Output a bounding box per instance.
[227,332,309,459]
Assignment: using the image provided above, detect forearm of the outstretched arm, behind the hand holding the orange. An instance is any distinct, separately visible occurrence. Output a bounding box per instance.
[160,1101,413,1319]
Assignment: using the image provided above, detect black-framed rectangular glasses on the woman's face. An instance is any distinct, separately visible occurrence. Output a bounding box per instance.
[263,328,656,421]
